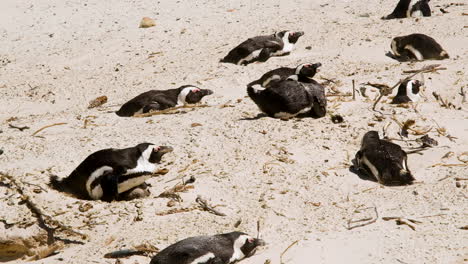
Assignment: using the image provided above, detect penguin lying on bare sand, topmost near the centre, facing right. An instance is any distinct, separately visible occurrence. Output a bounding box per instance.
[220,31,304,66]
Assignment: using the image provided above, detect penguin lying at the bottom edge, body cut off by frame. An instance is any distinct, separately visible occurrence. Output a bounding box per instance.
[150,232,265,264]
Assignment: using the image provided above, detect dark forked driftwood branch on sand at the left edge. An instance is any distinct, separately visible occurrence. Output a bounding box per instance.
[0,172,87,245]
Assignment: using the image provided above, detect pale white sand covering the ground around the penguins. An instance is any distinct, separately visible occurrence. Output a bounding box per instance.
[0,0,468,264]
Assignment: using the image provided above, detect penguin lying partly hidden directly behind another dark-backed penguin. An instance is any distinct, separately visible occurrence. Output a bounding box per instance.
[247,63,322,88]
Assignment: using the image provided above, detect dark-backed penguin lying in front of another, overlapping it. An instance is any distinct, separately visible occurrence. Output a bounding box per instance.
[247,75,327,119]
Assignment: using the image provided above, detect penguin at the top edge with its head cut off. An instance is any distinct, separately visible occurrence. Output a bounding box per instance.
[382,0,431,20]
